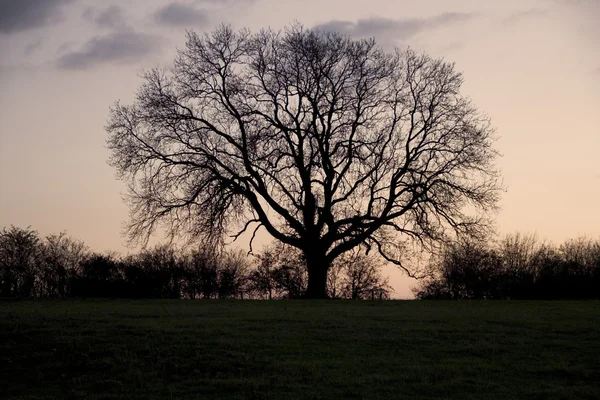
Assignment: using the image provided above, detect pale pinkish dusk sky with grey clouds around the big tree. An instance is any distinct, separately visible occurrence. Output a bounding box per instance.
[0,0,600,298]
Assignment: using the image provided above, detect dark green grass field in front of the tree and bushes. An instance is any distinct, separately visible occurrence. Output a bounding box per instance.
[0,300,600,400]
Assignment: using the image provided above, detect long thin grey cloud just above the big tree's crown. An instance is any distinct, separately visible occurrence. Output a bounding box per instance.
[315,13,473,39]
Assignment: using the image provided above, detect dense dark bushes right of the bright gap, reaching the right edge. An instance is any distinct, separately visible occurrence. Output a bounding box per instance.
[414,234,600,299]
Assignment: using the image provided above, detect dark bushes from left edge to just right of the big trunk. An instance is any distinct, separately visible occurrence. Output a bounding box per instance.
[0,226,391,300]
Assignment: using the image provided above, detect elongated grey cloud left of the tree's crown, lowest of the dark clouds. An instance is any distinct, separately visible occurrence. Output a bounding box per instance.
[57,31,159,69]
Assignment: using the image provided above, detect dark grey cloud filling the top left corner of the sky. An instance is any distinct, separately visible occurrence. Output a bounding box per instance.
[0,0,72,33]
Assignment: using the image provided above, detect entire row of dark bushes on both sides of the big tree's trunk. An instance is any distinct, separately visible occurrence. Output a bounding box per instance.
[0,227,600,300]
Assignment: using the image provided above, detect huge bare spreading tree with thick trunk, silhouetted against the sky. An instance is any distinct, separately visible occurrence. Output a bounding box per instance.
[106,25,499,298]
